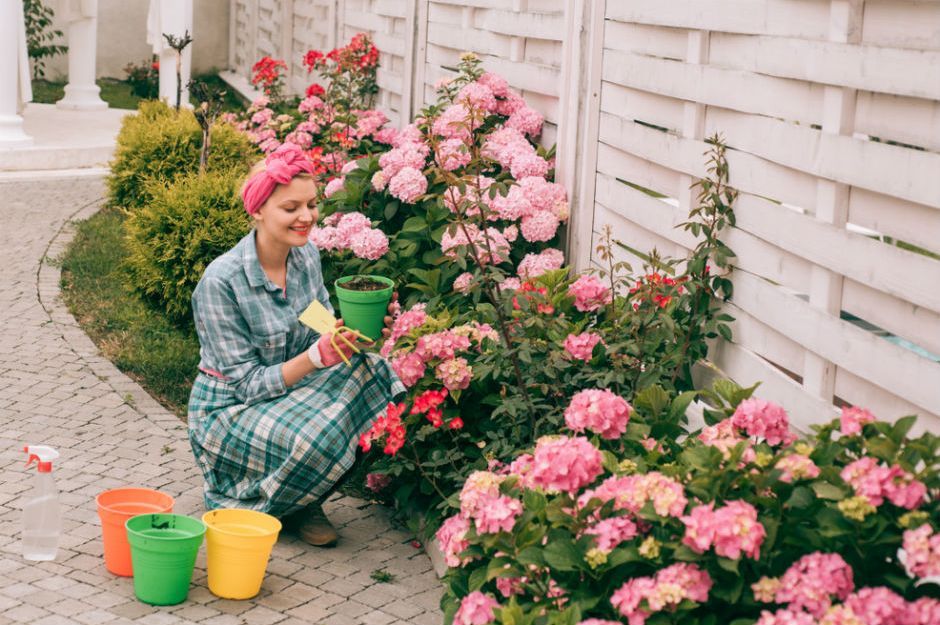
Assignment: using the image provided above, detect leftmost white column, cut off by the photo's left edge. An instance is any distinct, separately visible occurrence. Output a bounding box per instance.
[0,2,33,147]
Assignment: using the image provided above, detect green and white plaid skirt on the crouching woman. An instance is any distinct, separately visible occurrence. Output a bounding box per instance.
[189,354,405,517]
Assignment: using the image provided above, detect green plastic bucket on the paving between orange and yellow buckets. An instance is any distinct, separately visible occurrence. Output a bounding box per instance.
[126,514,206,605]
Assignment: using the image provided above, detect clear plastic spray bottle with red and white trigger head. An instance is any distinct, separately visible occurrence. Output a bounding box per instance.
[23,445,62,560]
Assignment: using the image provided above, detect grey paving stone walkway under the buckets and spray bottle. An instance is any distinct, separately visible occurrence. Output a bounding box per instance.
[0,176,442,625]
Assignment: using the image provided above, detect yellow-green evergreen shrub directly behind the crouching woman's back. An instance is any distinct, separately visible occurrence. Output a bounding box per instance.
[125,169,251,323]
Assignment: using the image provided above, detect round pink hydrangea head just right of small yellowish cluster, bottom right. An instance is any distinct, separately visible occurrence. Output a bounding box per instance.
[774,551,855,618]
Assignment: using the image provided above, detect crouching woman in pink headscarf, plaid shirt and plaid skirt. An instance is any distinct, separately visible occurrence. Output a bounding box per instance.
[189,144,405,545]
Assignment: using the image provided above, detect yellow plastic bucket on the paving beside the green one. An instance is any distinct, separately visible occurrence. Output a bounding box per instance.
[202,508,281,599]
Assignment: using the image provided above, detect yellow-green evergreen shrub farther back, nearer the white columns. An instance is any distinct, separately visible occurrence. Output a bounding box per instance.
[108,102,260,210]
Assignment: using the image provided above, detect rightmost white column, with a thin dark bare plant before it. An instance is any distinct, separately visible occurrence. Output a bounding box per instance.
[147,0,193,108]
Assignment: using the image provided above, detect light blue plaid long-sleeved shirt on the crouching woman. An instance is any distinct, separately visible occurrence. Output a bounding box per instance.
[192,230,333,405]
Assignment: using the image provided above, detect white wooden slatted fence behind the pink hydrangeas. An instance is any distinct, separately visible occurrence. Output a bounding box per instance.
[230,0,940,430]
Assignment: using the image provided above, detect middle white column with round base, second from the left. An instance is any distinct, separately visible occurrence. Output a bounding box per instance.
[56,0,108,111]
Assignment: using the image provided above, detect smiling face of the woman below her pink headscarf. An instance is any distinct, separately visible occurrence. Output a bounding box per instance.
[255,176,317,247]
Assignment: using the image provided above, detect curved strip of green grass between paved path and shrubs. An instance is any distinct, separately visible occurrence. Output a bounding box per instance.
[62,209,199,418]
